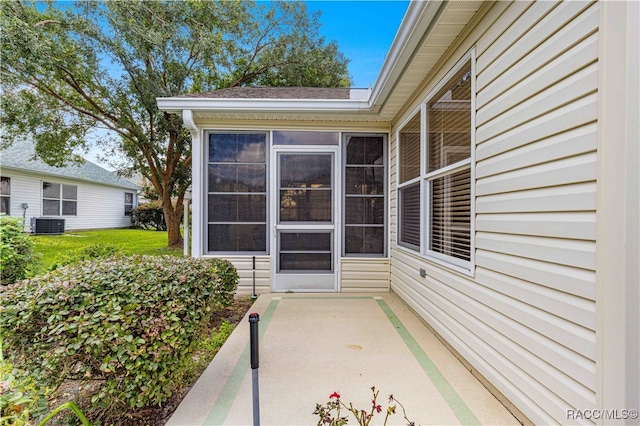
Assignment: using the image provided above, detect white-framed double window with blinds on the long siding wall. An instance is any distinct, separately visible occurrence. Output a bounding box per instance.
[398,54,472,268]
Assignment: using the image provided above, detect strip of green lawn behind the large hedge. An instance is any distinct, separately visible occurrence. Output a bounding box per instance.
[31,229,183,271]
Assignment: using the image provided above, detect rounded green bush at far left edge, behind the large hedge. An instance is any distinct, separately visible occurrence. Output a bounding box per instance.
[0,216,37,285]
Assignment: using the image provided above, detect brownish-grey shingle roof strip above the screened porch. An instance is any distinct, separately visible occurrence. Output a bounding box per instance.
[185,86,351,99]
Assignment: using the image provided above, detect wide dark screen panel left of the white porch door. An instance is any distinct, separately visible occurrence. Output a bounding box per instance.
[207,132,267,253]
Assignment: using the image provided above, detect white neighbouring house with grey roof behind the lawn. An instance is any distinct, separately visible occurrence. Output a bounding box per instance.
[0,140,140,232]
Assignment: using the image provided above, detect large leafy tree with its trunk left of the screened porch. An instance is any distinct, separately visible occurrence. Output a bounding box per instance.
[0,0,351,245]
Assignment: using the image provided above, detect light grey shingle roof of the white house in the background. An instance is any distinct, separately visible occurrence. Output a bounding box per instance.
[0,139,140,189]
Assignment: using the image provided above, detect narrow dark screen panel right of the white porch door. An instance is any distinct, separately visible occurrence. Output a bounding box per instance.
[344,135,387,256]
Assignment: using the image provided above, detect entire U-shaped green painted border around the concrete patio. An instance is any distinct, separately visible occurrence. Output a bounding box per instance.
[204,296,480,425]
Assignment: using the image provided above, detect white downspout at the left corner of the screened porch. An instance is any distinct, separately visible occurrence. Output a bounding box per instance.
[182,110,204,257]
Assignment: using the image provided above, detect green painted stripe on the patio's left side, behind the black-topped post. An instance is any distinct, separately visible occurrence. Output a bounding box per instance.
[204,297,280,425]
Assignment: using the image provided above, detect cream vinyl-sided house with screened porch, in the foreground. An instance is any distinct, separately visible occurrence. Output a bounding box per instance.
[158,1,640,425]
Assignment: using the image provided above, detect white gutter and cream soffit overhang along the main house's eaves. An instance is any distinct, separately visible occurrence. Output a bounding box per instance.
[157,0,483,123]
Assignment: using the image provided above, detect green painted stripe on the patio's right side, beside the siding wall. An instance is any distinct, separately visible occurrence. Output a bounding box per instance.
[374,297,481,425]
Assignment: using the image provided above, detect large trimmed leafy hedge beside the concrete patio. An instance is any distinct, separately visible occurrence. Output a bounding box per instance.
[0,255,238,419]
